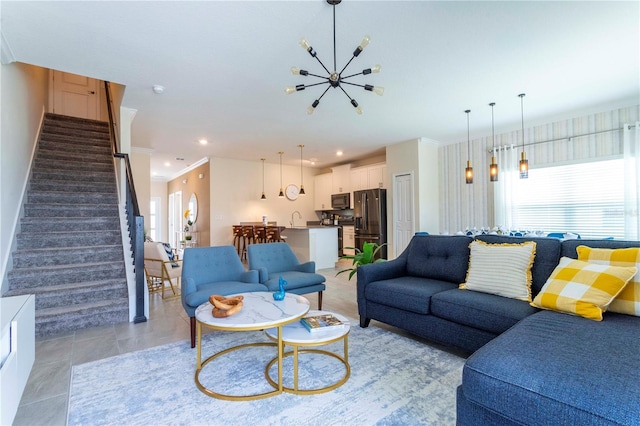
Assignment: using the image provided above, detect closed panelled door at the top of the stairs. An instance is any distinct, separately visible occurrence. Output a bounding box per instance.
[53,71,100,120]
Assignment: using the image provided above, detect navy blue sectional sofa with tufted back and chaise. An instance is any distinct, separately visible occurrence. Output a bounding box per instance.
[357,235,640,425]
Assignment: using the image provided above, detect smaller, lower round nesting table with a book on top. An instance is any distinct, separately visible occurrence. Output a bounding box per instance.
[265,311,351,395]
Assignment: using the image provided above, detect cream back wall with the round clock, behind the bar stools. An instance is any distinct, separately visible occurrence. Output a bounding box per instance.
[210,158,318,245]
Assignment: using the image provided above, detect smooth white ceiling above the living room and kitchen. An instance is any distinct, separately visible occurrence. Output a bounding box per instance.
[0,0,640,178]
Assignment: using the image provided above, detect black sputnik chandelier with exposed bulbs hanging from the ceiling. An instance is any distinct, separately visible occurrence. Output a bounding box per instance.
[285,0,384,114]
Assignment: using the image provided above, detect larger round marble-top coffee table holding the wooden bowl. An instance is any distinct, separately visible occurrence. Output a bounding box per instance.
[194,291,310,401]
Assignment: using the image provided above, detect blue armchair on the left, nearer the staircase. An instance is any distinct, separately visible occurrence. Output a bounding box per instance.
[181,246,267,348]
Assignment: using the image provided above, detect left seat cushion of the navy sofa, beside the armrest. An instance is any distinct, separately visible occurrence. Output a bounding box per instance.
[365,276,457,314]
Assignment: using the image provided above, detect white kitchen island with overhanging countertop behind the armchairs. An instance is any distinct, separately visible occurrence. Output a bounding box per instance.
[281,226,338,269]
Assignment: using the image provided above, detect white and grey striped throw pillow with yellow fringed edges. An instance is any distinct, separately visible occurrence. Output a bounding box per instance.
[460,241,536,302]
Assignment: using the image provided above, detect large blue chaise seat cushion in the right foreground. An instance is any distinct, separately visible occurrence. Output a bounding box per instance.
[462,311,640,425]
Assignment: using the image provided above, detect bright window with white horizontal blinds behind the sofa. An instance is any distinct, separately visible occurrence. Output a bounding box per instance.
[512,159,625,239]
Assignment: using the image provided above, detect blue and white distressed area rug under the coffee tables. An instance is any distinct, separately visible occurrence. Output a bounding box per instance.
[67,322,464,426]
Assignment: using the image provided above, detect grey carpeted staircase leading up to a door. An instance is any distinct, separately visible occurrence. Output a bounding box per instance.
[4,114,129,336]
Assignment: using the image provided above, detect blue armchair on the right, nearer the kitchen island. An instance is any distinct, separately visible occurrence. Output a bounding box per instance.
[247,243,325,310]
